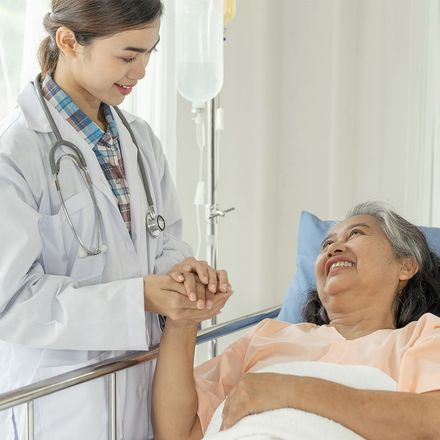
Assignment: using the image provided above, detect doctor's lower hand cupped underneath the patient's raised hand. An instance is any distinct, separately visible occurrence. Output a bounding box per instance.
[144,275,230,322]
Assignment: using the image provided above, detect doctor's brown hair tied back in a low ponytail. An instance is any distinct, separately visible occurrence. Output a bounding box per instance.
[38,0,163,77]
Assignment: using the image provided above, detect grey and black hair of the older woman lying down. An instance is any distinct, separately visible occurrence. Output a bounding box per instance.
[303,202,440,328]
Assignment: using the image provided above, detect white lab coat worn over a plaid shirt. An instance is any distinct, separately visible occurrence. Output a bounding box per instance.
[0,83,191,440]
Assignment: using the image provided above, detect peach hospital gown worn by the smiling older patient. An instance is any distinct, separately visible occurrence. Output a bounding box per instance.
[194,313,440,431]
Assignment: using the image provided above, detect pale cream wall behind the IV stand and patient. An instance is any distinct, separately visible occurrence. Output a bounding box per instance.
[177,0,437,356]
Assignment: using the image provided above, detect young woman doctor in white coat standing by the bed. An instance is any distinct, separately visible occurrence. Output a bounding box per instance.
[0,0,231,440]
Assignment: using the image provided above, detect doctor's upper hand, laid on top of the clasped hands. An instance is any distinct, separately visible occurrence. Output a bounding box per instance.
[168,257,232,308]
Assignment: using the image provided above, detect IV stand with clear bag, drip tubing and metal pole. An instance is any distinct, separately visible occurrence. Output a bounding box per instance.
[176,0,236,357]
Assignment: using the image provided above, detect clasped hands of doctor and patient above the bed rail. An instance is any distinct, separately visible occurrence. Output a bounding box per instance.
[144,257,232,322]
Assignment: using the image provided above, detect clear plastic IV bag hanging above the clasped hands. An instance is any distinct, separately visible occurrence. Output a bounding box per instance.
[176,0,224,108]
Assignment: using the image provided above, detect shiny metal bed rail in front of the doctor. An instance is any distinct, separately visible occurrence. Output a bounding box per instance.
[0,306,281,440]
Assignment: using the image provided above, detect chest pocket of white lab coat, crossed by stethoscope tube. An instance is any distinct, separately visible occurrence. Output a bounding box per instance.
[40,189,105,285]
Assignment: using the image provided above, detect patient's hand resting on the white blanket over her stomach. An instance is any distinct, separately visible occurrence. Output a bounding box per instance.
[221,373,293,430]
